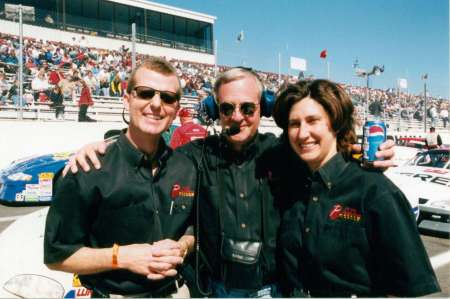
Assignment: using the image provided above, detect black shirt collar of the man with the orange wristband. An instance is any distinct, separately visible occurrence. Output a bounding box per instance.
[117,132,171,167]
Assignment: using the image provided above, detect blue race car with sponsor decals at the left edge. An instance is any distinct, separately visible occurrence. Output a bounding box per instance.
[0,152,71,206]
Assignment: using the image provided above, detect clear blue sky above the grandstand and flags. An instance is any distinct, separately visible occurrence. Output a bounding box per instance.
[155,0,450,98]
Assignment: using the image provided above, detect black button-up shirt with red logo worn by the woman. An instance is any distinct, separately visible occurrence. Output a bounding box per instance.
[280,154,439,297]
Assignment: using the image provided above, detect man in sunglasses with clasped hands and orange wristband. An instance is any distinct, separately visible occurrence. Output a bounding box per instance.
[44,58,195,297]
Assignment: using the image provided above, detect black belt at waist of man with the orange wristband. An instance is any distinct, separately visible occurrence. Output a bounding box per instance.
[90,278,184,298]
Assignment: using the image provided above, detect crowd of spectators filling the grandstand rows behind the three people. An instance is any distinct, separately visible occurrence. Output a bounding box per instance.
[0,33,448,125]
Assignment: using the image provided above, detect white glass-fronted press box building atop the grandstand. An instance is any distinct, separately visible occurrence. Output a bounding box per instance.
[0,0,216,64]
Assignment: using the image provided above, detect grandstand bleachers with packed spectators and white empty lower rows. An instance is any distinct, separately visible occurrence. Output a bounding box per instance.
[0,33,448,130]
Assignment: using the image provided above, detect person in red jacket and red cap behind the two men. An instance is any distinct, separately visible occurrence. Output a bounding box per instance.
[170,108,208,149]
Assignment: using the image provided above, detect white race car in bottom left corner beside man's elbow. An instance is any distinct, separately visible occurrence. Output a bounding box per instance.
[0,207,91,298]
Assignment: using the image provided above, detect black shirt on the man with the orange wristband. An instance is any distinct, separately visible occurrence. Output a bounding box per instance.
[44,133,195,294]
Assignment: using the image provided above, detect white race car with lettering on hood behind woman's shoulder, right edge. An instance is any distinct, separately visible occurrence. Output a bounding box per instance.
[386,149,450,236]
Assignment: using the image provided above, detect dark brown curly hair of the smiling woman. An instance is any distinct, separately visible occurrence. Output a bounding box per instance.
[273,79,356,156]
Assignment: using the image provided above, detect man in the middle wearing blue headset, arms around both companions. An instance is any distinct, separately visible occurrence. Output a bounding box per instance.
[64,68,393,298]
